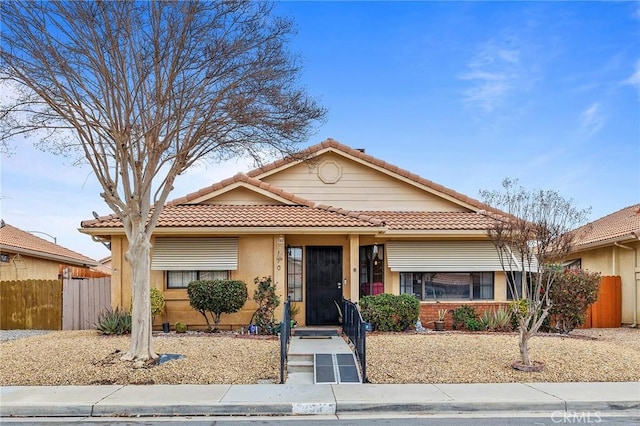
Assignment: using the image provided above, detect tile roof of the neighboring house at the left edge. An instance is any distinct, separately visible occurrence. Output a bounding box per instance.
[0,222,98,266]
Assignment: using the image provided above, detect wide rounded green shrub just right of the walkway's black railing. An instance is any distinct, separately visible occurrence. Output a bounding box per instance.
[360,293,420,331]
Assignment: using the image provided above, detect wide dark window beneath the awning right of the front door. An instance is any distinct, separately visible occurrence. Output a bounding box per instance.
[400,272,494,300]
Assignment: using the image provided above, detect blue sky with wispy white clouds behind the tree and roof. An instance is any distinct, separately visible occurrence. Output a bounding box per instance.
[0,2,640,259]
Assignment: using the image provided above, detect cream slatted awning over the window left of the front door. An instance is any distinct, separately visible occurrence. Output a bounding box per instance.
[151,238,238,271]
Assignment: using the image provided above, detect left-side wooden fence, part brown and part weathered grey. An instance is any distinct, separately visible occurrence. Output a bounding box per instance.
[0,278,111,330]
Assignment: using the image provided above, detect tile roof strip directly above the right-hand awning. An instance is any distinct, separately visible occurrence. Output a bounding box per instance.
[362,211,493,231]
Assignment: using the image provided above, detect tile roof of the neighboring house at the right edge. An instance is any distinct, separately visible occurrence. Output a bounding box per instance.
[573,204,640,249]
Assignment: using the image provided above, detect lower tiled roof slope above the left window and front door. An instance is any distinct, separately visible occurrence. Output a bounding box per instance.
[82,204,382,229]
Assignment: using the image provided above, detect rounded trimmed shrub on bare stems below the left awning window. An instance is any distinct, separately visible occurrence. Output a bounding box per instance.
[187,280,247,331]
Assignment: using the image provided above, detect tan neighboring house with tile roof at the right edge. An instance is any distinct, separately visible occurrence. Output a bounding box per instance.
[566,204,640,326]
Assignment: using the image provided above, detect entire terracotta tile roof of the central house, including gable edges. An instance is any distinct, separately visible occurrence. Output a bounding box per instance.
[81,139,505,232]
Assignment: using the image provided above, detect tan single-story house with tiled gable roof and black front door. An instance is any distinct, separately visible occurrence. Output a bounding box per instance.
[77,139,524,328]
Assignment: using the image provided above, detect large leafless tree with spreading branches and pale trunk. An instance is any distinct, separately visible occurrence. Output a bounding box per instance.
[0,0,325,360]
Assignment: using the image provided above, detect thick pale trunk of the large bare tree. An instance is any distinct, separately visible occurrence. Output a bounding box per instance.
[122,231,158,361]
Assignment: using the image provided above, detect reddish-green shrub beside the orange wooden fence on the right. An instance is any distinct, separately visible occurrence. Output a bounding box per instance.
[549,269,600,333]
